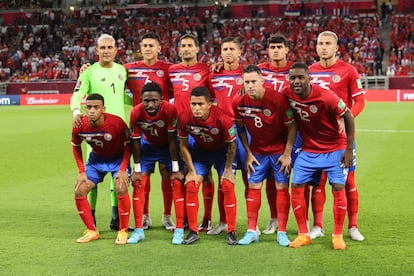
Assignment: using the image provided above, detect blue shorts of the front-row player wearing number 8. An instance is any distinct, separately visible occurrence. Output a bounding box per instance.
[248,154,289,184]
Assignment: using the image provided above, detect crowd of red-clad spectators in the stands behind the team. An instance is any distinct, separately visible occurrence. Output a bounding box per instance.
[0,1,414,82]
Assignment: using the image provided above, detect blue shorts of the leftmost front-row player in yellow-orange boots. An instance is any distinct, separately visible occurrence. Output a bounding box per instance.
[85,152,131,185]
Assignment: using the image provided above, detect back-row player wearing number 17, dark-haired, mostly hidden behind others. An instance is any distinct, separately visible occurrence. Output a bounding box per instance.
[258,34,300,234]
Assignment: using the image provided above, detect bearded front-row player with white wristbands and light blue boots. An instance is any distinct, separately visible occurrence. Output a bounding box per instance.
[128,82,184,244]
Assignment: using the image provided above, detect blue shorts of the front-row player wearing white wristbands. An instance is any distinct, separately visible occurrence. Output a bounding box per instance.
[140,139,171,173]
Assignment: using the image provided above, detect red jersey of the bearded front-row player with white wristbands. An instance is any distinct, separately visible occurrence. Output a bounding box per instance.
[130,101,177,147]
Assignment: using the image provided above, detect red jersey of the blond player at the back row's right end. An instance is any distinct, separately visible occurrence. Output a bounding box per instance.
[309,60,365,107]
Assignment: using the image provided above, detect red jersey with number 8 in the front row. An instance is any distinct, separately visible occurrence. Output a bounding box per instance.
[233,88,294,155]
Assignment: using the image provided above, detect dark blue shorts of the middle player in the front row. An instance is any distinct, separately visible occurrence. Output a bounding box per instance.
[191,147,236,177]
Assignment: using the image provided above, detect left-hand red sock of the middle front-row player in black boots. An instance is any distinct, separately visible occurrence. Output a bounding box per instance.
[185,181,201,233]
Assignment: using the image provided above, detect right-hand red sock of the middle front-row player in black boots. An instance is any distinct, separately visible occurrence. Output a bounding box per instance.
[221,179,237,233]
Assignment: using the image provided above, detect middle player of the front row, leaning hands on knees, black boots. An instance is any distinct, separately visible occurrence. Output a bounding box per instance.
[178,86,237,245]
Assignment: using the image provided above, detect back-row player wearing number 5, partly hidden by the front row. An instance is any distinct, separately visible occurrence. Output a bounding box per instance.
[168,34,214,231]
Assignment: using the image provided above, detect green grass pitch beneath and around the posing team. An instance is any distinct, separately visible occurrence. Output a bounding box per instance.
[0,103,414,275]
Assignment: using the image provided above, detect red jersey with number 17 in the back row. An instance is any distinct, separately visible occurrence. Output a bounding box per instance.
[258,61,293,92]
